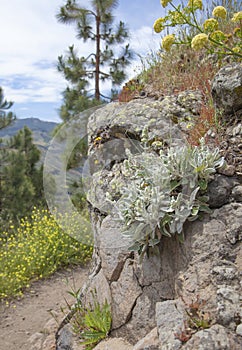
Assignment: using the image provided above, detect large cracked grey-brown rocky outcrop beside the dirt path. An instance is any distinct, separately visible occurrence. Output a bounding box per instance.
[55,65,242,350]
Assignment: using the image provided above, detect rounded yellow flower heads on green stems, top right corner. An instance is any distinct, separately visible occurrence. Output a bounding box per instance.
[154,0,242,59]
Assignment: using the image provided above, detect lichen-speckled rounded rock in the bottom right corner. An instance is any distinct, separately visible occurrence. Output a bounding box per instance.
[182,325,242,350]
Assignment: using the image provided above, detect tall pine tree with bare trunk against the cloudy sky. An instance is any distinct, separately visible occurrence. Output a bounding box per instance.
[57,0,132,120]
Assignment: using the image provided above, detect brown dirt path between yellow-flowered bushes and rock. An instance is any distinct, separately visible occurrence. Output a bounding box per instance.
[0,267,88,350]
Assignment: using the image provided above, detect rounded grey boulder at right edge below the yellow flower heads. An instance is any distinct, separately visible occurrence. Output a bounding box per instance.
[212,63,242,115]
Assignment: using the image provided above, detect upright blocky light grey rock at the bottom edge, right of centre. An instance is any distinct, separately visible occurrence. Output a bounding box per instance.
[156,300,184,350]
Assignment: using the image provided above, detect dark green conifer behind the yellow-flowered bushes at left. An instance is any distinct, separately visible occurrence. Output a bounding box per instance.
[0,127,45,229]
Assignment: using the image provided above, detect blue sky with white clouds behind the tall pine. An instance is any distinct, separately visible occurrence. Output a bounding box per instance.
[0,0,164,122]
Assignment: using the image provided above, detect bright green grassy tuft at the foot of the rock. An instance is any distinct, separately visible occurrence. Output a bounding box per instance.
[72,292,112,350]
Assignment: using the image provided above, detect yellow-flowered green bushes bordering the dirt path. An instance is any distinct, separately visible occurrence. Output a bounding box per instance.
[0,209,92,299]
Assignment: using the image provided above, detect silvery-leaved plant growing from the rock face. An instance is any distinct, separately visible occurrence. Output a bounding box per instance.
[108,142,224,256]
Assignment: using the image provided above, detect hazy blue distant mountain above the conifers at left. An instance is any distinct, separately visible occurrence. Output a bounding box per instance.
[0,118,58,152]
